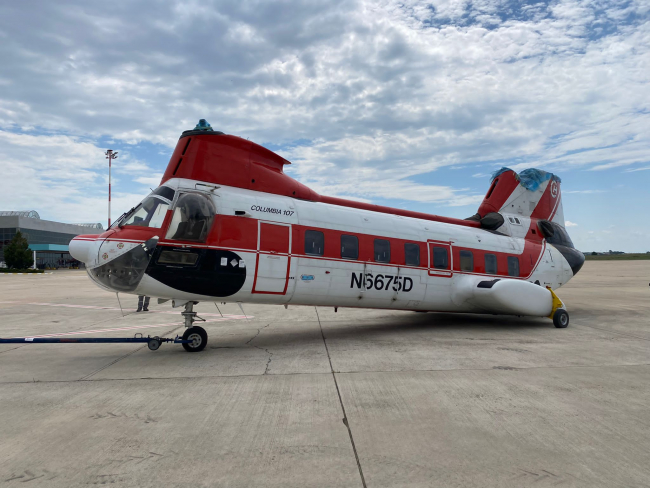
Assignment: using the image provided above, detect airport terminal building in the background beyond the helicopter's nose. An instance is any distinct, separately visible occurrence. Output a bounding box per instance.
[0,210,104,268]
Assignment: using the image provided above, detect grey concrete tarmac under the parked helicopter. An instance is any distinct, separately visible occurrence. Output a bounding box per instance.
[0,261,650,488]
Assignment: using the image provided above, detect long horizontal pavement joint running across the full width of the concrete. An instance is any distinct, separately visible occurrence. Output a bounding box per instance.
[0,364,650,386]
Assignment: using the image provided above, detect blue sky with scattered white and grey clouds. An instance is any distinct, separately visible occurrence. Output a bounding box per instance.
[0,0,650,252]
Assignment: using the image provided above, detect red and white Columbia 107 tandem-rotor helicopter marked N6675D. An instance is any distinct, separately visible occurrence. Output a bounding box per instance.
[70,119,584,351]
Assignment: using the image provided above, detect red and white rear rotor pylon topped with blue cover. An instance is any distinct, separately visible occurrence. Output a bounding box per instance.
[478,168,564,223]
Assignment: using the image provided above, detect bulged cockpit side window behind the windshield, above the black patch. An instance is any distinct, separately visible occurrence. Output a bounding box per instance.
[167,193,216,242]
